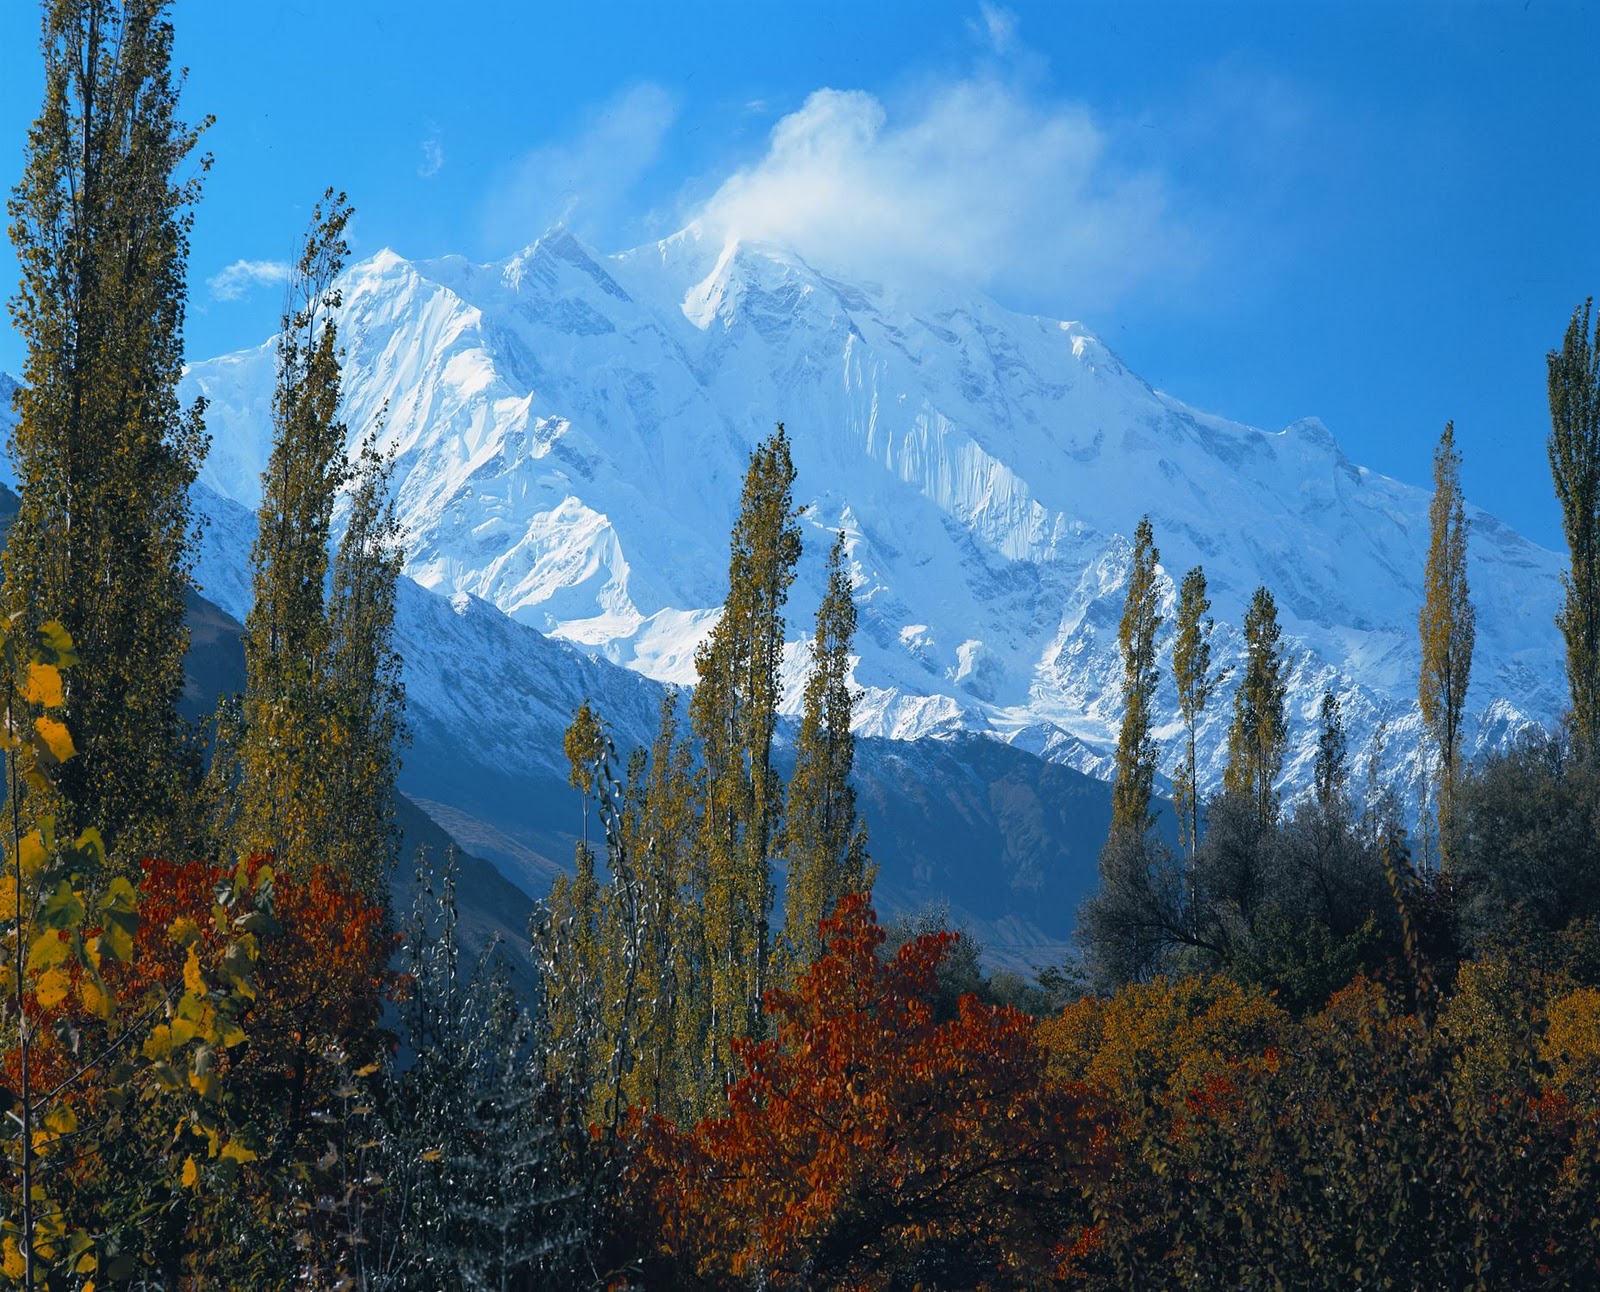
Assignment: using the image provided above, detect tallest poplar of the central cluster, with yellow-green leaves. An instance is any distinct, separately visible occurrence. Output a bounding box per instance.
[690,422,800,1092]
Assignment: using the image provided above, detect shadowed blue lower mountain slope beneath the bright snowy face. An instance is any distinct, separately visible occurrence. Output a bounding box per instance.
[197,485,1110,971]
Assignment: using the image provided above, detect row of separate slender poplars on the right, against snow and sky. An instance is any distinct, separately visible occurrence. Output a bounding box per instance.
[1110,299,1600,867]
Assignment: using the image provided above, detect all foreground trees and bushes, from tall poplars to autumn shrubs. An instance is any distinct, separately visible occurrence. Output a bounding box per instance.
[0,0,1600,1292]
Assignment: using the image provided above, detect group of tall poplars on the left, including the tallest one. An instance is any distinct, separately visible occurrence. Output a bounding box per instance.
[3,0,403,892]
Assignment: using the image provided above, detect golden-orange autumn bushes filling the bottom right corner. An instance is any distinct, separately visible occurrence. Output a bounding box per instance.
[1042,979,1600,1289]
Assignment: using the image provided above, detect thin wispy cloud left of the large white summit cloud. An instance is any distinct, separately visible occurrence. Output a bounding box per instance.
[483,83,678,249]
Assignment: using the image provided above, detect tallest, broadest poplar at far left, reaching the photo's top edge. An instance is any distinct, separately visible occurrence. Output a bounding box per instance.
[5,0,208,870]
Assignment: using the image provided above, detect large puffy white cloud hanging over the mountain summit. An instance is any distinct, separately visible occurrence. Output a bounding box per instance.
[699,77,1195,313]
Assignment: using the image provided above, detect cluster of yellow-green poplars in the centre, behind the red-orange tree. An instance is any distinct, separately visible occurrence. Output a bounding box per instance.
[536,425,872,1131]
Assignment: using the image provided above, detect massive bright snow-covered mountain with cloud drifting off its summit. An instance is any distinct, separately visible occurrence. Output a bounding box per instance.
[189,229,1565,805]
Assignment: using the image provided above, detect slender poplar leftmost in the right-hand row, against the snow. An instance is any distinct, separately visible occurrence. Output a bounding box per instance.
[1110,516,1162,835]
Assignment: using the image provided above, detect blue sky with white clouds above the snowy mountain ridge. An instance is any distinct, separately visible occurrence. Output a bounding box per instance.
[0,0,1600,547]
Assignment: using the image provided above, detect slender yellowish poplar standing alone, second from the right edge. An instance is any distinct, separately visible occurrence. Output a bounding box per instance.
[1416,422,1475,863]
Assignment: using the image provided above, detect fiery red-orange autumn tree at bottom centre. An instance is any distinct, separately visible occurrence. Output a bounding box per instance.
[632,894,1104,1287]
